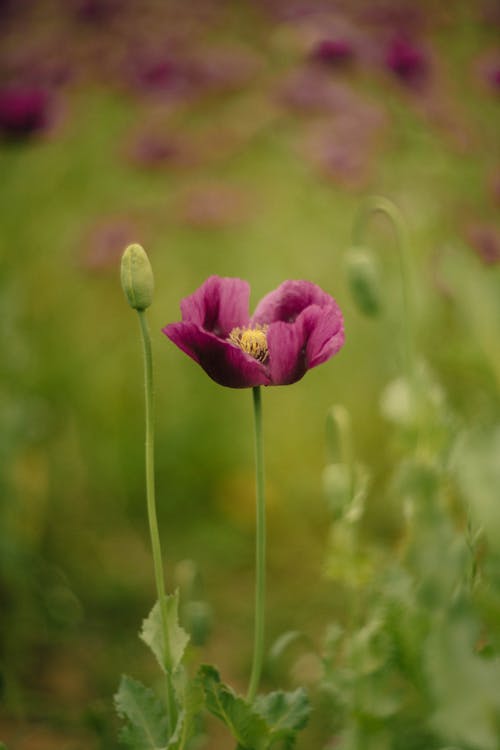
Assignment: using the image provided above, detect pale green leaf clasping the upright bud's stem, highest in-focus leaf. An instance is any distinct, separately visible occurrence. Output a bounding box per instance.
[140,591,189,672]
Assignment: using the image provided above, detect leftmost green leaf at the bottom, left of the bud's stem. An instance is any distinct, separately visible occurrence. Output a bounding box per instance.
[115,675,168,750]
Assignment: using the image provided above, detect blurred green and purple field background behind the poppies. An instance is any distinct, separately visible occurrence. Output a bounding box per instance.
[0,0,500,750]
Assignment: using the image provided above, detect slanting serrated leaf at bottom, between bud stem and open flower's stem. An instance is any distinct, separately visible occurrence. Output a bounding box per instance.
[199,665,270,750]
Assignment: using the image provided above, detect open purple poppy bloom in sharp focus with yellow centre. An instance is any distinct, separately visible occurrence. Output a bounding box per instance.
[163,276,344,388]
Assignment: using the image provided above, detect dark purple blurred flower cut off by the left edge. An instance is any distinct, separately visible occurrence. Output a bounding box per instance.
[0,86,50,139]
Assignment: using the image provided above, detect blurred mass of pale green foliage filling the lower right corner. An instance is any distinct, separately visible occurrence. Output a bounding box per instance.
[314,367,500,750]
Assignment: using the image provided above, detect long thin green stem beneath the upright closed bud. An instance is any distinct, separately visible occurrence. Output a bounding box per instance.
[137,310,177,731]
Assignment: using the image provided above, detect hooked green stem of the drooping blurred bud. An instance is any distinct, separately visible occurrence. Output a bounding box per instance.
[352,196,415,379]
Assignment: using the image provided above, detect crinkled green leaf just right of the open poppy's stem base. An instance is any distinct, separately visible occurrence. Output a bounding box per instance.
[253,688,311,747]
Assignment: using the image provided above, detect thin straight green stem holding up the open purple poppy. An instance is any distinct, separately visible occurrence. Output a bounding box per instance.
[247,386,266,702]
